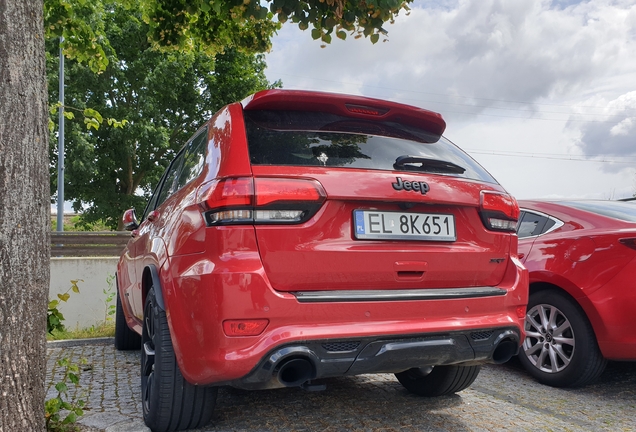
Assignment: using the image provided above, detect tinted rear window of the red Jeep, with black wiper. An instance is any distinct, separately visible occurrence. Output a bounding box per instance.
[244,111,497,183]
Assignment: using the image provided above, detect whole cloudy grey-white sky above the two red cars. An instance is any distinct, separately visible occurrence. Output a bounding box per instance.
[266,0,636,199]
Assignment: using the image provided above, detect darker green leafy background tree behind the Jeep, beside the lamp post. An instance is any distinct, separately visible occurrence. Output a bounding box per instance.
[48,3,280,228]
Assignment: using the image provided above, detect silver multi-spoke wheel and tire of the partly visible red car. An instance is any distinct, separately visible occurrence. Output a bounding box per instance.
[519,290,607,387]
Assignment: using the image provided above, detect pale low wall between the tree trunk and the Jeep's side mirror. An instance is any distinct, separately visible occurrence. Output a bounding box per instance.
[49,257,118,330]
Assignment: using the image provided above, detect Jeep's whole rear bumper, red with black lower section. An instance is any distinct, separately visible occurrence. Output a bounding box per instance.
[160,253,528,389]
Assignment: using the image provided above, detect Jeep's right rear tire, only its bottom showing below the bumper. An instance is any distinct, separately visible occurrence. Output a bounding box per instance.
[395,365,481,397]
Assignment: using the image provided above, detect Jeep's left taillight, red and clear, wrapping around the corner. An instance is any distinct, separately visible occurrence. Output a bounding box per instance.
[199,177,327,225]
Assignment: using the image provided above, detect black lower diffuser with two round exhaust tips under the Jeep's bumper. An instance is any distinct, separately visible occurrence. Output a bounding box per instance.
[227,328,520,390]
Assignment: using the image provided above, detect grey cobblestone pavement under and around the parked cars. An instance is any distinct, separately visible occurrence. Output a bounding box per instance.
[47,344,636,432]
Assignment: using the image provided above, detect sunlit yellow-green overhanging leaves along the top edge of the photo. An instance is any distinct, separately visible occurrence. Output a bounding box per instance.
[44,0,413,72]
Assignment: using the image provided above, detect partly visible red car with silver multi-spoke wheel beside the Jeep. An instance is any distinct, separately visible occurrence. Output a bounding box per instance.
[517,201,636,387]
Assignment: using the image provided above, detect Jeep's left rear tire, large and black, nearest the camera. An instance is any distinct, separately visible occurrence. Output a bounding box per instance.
[141,288,218,432]
